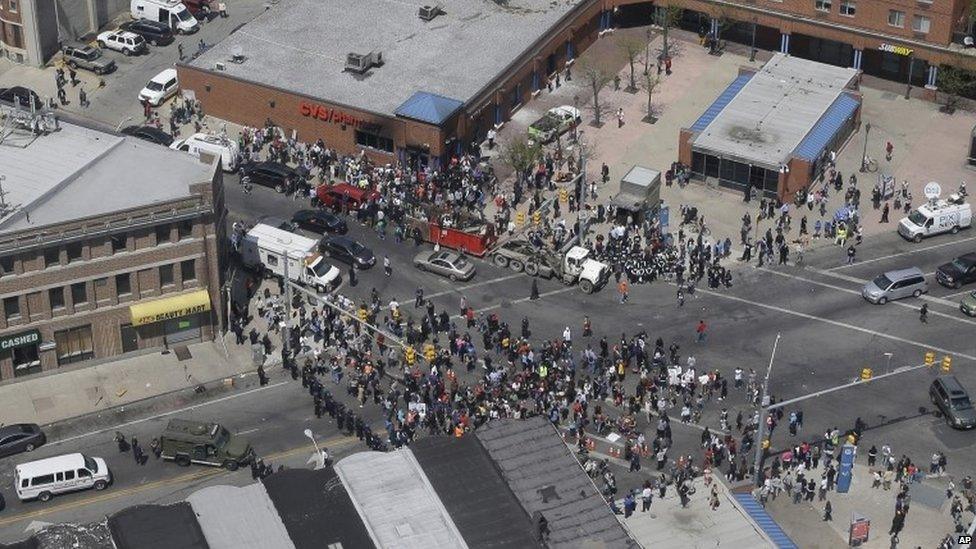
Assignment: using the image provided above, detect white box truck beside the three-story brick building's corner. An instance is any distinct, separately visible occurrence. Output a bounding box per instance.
[237,223,339,292]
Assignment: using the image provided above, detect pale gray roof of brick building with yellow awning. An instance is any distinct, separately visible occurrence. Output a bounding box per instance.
[0,121,216,234]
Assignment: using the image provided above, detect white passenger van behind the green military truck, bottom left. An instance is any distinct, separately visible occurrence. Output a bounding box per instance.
[14,454,112,501]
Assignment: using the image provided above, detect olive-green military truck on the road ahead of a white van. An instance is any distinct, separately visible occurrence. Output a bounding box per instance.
[159,419,254,471]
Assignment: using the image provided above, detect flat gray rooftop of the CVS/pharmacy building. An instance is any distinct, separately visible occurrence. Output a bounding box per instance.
[190,0,584,115]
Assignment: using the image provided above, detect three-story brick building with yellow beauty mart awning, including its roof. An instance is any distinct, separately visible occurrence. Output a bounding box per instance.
[0,115,226,381]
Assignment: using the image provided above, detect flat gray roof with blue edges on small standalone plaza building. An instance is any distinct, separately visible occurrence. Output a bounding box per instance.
[694,53,858,170]
